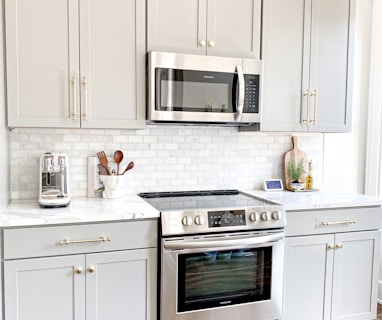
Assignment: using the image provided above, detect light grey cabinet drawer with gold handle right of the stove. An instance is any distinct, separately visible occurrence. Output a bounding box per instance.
[285,207,382,236]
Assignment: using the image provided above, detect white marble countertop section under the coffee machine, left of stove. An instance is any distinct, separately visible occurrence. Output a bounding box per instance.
[0,195,159,227]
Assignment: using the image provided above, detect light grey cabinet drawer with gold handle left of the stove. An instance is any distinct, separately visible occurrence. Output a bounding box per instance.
[4,220,158,259]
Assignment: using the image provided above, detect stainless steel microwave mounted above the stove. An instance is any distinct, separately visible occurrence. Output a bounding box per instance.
[147,51,263,126]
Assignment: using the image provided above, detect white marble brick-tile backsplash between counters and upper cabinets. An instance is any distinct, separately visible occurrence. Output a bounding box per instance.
[10,126,323,199]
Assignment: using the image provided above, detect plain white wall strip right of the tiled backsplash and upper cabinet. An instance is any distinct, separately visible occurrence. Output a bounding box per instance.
[323,0,379,193]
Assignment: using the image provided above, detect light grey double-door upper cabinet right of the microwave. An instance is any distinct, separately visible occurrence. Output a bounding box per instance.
[260,0,355,132]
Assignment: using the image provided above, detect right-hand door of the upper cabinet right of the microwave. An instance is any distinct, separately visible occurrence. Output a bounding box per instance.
[304,0,355,132]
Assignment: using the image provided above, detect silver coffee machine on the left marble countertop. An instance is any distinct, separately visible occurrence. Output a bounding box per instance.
[39,152,70,208]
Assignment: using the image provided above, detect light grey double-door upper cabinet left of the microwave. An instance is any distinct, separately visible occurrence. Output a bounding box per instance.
[5,0,145,128]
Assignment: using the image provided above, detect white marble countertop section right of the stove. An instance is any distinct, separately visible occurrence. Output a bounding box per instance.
[244,190,382,211]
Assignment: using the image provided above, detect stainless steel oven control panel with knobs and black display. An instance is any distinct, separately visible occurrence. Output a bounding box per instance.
[161,206,286,236]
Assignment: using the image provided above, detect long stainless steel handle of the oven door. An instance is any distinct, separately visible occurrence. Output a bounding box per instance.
[164,232,284,250]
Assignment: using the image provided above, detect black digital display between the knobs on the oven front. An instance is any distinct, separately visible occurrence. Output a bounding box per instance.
[208,210,246,228]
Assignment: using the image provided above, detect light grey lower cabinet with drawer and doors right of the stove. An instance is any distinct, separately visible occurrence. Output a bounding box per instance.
[283,208,381,320]
